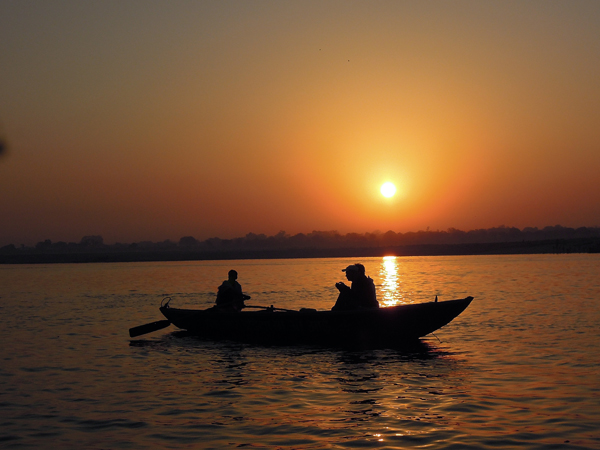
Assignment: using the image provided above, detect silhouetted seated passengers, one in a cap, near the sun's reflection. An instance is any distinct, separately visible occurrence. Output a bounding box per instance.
[331,264,379,311]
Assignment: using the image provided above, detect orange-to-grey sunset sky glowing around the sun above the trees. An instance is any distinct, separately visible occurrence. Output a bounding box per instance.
[0,0,600,246]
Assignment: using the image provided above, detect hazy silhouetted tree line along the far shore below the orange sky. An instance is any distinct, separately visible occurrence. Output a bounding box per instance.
[0,225,600,254]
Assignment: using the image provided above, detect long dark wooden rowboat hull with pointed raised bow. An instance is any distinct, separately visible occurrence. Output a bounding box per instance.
[156,297,473,343]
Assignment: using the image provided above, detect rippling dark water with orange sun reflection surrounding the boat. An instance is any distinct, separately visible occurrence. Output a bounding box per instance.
[0,255,600,449]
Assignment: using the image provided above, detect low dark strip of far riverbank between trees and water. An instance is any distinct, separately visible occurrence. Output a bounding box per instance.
[0,237,600,264]
